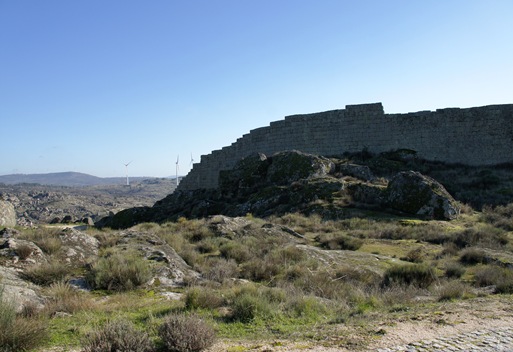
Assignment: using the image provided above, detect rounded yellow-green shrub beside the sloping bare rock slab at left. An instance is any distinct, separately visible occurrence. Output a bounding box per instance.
[87,252,151,291]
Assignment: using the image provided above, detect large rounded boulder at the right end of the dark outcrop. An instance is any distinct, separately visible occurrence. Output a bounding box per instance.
[386,171,459,220]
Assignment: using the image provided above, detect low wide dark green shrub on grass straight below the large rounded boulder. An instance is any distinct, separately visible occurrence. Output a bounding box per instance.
[383,264,436,288]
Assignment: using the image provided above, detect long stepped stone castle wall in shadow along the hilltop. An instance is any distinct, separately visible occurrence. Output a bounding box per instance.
[178,103,513,190]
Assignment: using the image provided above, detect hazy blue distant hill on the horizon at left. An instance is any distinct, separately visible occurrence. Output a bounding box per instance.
[0,171,158,187]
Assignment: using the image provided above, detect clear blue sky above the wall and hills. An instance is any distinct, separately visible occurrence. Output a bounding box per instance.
[0,0,513,177]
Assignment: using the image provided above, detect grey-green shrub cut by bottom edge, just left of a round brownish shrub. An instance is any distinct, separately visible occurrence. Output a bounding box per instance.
[82,320,154,352]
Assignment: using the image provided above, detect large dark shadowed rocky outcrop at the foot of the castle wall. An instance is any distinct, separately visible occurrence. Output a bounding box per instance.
[97,151,459,228]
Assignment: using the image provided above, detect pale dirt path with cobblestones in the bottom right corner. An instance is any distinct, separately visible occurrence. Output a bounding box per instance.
[208,297,513,352]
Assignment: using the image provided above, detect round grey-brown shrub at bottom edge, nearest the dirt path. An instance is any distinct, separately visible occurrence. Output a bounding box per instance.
[158,314,215,352]
